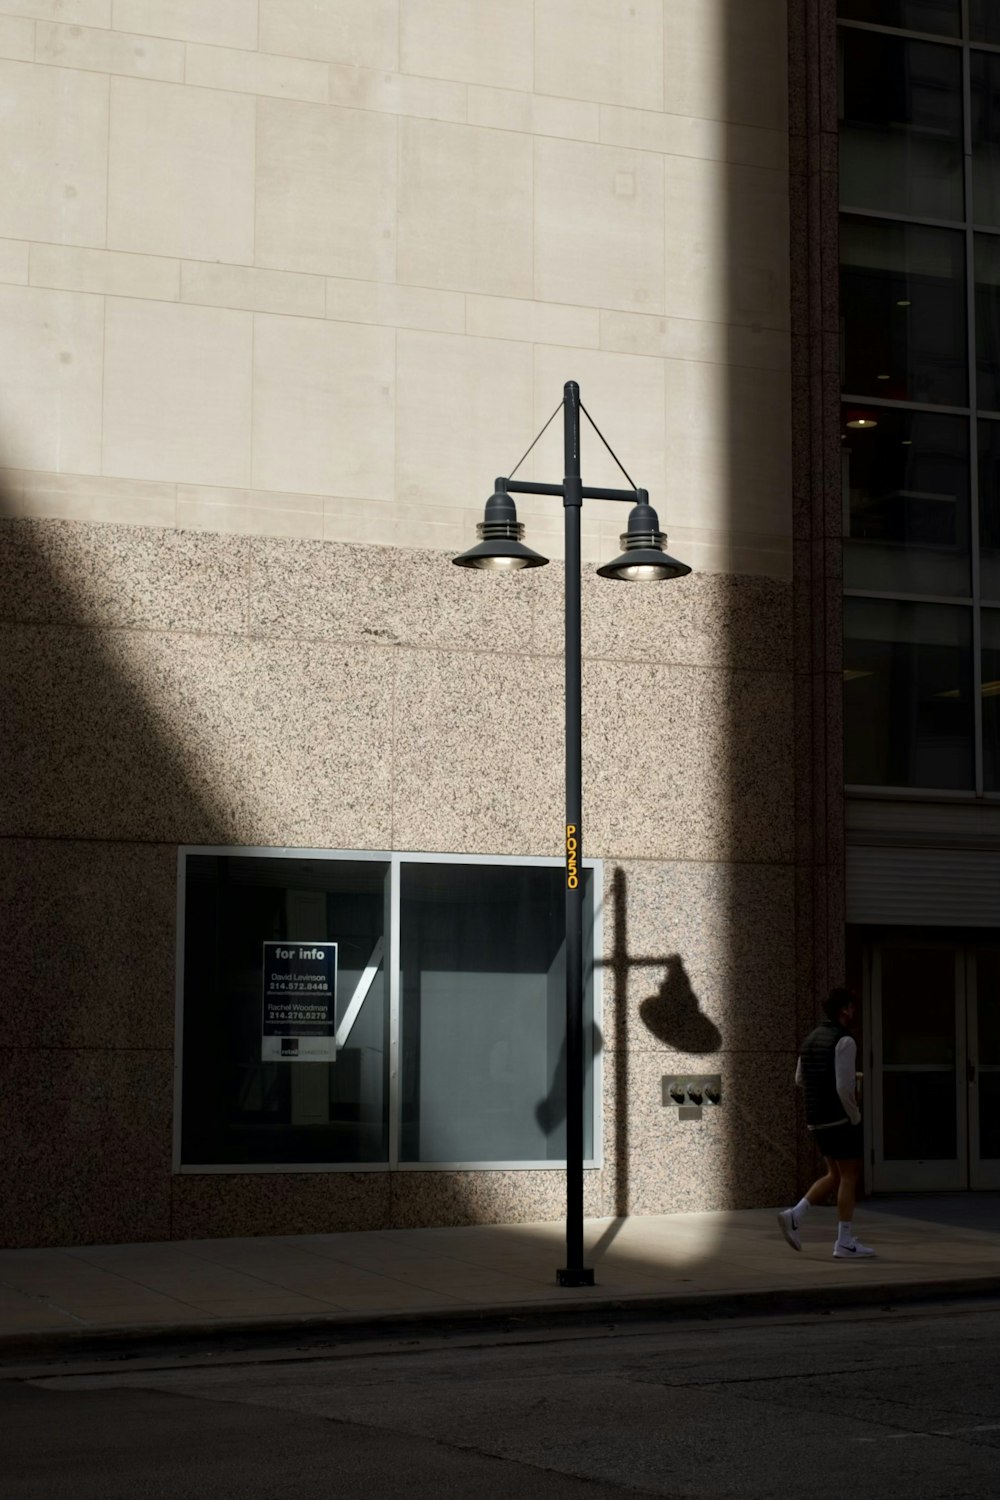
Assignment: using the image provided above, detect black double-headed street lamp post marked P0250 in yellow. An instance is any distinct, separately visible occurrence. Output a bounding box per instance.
[451,381,691,1287]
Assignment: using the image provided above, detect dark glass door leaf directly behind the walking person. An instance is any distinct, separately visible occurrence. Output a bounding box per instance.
[868,942,969,1193]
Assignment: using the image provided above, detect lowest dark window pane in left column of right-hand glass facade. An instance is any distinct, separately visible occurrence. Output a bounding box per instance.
[844,599,975,791]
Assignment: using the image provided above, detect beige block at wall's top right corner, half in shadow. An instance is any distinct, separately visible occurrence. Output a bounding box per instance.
[665,0,789,131]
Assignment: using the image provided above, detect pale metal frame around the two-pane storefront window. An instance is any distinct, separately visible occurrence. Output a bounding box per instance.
[171,845,606,1176]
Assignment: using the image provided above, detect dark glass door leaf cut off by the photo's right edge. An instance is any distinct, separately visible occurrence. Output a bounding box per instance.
[967,948,1000,1188]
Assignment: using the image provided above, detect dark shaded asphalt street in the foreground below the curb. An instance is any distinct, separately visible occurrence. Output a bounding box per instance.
[0,1301,1000,1500]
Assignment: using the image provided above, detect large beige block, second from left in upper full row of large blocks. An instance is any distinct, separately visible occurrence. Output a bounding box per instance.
[108,78,255,261]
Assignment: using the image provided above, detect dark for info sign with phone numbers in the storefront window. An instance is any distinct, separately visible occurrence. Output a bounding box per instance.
[261,942,337,1062]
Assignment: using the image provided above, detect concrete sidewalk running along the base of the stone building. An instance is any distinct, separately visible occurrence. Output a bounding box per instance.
[0,1194,1000,1353]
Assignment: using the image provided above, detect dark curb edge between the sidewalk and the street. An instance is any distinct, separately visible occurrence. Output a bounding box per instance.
[0,1275,1000,1361]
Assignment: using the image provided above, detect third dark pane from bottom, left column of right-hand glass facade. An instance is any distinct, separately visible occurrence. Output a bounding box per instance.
[840,215,969,407]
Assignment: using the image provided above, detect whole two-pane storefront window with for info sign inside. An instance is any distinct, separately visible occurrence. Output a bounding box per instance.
[175,849,595,1172]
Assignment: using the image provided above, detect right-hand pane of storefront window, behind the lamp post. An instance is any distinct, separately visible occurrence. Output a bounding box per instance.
[400,864,594,1163]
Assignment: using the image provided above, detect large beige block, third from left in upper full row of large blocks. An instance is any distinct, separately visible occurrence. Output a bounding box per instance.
[256,99,396,281]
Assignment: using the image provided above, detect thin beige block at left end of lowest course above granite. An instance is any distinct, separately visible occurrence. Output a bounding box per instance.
[0,470,177,527]
